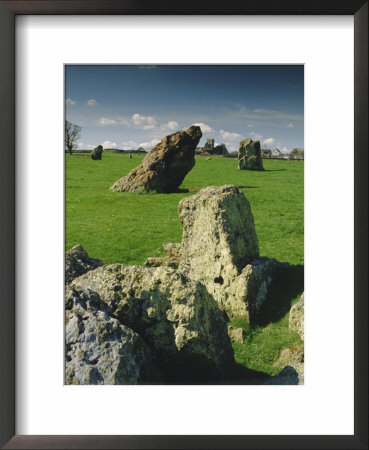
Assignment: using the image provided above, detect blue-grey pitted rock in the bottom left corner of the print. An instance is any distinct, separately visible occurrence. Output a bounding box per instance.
[65,286,160,384]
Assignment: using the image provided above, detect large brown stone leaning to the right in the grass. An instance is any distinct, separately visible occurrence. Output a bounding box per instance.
[110,125,202,193]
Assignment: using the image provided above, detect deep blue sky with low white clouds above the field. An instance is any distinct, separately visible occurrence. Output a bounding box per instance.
[65,65,304,152]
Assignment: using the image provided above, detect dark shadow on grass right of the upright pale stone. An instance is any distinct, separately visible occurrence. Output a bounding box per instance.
[254,265,304,327]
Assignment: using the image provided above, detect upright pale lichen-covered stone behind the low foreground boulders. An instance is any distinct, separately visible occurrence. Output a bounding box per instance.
[178,185,278,321]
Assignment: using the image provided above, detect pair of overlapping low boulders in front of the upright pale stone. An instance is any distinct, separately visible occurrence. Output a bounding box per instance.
[66,264,234,384]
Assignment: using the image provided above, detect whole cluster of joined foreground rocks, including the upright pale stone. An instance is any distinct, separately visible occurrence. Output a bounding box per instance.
[66,185,286,384]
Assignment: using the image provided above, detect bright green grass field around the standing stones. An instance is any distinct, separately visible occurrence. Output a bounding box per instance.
[65,151,304,374]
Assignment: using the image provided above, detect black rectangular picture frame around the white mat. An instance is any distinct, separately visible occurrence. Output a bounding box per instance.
[0,0,368,449]
